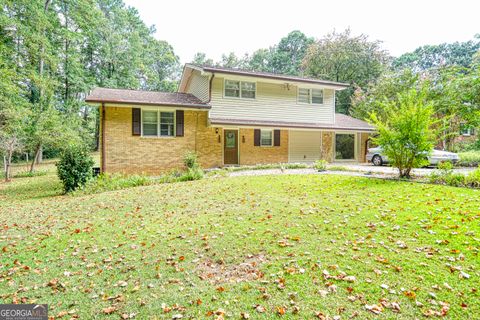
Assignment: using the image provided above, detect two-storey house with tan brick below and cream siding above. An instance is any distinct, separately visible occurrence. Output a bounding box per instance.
[86,64,374,174]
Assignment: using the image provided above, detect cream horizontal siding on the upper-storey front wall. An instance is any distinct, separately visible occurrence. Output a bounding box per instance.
[210,76,335,123]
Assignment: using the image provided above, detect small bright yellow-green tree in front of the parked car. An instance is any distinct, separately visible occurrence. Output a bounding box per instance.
[371,89,434,178]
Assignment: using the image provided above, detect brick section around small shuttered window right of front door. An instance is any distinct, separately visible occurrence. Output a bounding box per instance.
[239,129,288,165]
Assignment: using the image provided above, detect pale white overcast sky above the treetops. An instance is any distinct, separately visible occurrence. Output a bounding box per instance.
[124,0,480,63]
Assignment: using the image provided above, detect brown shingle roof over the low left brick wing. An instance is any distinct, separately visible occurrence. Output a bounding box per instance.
[85,88,210,109]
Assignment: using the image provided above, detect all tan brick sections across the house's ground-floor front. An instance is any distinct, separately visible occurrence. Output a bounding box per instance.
[101,107,369,175]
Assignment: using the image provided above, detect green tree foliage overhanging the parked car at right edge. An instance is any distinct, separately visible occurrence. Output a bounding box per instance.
[350,66,480,150]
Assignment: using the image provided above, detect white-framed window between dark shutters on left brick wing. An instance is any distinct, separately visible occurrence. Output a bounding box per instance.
[142,110,175,137]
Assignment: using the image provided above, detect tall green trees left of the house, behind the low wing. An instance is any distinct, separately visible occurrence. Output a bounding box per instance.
[0,0,179,169]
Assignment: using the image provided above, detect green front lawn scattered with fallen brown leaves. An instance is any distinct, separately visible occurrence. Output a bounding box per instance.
[0,174,480,319]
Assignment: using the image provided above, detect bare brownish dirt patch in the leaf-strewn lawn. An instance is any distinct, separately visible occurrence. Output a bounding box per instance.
[197,254,267,284]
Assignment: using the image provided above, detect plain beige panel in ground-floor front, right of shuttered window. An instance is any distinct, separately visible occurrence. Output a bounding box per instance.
[288,130,322,163]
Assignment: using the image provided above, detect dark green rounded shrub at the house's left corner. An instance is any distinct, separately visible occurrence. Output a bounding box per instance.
[57,145,93,192]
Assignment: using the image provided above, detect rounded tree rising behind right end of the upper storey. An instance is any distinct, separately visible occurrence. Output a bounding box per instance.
[303,29,389,114]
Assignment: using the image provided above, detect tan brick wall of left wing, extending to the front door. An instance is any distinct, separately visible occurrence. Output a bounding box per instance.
[102,107,223,174]
